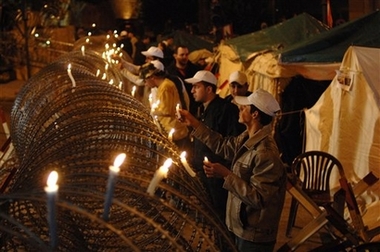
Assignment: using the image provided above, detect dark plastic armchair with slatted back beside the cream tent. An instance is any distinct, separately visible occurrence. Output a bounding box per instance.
[286,151,345,237]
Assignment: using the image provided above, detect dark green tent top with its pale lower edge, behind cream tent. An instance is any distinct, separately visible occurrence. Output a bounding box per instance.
[279,11,380,80]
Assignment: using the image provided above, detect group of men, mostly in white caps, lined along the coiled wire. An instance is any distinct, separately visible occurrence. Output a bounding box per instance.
[114,28,286,251]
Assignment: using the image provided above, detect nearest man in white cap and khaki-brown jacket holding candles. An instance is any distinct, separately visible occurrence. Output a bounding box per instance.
[179,89,286,251]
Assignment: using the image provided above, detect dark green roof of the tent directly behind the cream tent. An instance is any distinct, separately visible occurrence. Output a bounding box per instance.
[279,11,380,64]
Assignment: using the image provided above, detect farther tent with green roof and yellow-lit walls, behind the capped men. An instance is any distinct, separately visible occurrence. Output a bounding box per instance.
[218,13,328,97]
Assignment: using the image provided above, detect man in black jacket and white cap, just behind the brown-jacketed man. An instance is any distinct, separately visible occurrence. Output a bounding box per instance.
[185,70,240,220]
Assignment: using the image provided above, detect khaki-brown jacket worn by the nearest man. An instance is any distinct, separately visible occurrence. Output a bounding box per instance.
[192,124,286,242]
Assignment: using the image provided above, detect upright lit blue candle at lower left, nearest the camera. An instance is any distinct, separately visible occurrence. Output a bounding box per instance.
[45,171,58,248]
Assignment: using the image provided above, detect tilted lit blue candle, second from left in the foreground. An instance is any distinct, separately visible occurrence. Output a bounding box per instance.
[103,153,126,221]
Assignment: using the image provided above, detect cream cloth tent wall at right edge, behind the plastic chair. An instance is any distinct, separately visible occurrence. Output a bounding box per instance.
[305,46,380,198]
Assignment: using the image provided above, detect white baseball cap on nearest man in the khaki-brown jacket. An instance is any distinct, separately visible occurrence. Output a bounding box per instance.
[234,89,280,116]
